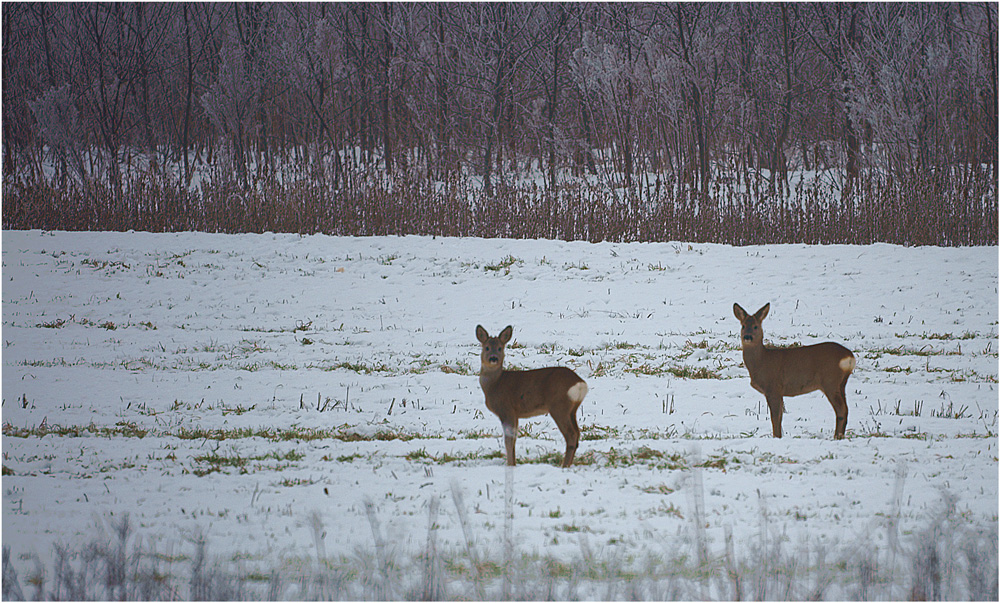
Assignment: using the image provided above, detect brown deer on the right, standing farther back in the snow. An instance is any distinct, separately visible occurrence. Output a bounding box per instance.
[733,304,856,440]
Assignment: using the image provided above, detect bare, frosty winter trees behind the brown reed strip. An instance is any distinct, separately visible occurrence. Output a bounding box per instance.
[3,3,997,241]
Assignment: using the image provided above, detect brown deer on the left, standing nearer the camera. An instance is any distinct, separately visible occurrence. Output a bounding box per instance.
[476,326,587,467]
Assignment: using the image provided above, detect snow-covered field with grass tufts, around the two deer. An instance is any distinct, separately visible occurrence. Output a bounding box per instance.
[2,231,998,596]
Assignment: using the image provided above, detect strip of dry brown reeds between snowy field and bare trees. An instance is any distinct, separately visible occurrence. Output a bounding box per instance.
[3,169,998,246]
